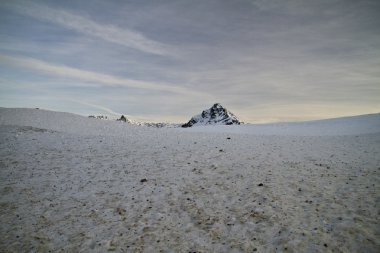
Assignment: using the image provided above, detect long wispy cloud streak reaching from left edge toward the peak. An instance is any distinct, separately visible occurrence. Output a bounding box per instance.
[0,54,202,96]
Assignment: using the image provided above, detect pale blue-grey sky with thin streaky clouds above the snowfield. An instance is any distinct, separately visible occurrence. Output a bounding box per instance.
[0,0,380,123]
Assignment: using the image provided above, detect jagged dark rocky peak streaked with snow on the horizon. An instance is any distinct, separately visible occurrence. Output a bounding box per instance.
[182,103,241,127]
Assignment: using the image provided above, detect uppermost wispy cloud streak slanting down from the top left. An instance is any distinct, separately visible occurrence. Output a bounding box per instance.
[9,1,173,56]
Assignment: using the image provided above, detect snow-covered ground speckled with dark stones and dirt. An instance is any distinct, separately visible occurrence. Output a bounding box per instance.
[0,108,380,252]
